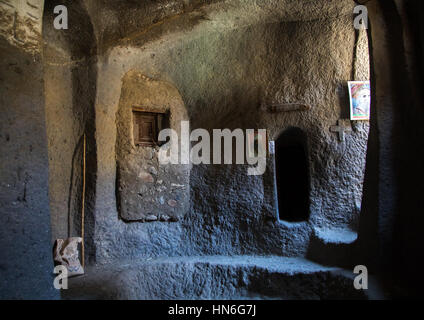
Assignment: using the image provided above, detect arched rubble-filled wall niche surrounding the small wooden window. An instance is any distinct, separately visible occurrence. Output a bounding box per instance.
[116,72,190,222]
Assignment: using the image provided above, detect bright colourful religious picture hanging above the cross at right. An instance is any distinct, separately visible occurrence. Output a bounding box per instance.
[348,81,371,120]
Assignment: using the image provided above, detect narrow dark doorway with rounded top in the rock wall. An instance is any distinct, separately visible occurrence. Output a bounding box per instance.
[275,128,310,222]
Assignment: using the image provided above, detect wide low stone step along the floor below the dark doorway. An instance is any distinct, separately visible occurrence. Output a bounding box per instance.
[62,256,378,300]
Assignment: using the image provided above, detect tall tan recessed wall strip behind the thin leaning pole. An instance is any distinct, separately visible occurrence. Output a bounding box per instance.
[43,1,97,261]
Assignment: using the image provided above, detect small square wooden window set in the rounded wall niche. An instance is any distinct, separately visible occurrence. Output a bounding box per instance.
[133,109,164,146]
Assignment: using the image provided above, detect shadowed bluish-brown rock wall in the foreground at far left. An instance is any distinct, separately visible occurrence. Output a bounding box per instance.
[0,1,58,299]
